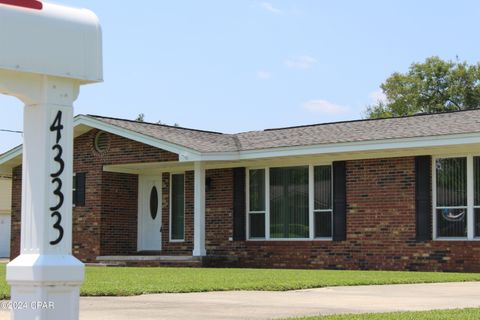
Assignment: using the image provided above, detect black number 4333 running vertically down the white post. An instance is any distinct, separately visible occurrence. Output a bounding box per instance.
[50,111,65,246]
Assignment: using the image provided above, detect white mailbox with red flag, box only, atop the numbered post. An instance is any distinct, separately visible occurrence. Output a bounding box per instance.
[0,0,103,83]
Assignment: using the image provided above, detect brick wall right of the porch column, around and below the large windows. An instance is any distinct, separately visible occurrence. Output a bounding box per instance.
[206,157,480,272]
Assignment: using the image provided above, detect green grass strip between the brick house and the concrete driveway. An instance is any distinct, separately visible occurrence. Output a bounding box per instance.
[0,264,480,299]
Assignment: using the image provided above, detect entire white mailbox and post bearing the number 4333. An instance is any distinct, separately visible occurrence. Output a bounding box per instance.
[0,0,102,320]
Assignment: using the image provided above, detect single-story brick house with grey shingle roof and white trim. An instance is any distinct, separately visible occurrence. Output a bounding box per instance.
[0,110,480,272]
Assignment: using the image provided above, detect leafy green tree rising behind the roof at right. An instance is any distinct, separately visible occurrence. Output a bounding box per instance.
[365,57,480,118]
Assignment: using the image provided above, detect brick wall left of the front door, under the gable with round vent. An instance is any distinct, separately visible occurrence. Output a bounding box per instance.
[11,129,178,262]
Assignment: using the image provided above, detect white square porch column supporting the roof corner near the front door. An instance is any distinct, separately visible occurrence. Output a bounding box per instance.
[193,161,206,257]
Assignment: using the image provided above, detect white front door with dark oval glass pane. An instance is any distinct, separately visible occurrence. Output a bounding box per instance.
[138,176,162,251]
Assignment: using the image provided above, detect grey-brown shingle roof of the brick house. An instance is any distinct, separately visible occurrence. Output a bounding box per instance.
[91,110,480,152]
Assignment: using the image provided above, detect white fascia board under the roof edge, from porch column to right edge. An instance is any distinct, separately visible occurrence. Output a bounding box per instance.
[201,133,480,161]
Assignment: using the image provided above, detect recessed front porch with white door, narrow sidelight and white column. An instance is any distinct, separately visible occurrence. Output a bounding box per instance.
[102,161,218,266]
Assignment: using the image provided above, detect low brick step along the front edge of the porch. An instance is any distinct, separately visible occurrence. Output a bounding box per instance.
[96,255,202,268]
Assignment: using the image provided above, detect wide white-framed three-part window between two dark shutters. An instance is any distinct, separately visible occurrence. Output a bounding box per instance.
[247,165,332,240]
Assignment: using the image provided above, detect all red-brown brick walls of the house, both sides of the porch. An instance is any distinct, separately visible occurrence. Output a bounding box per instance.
[11,138,480,272]
